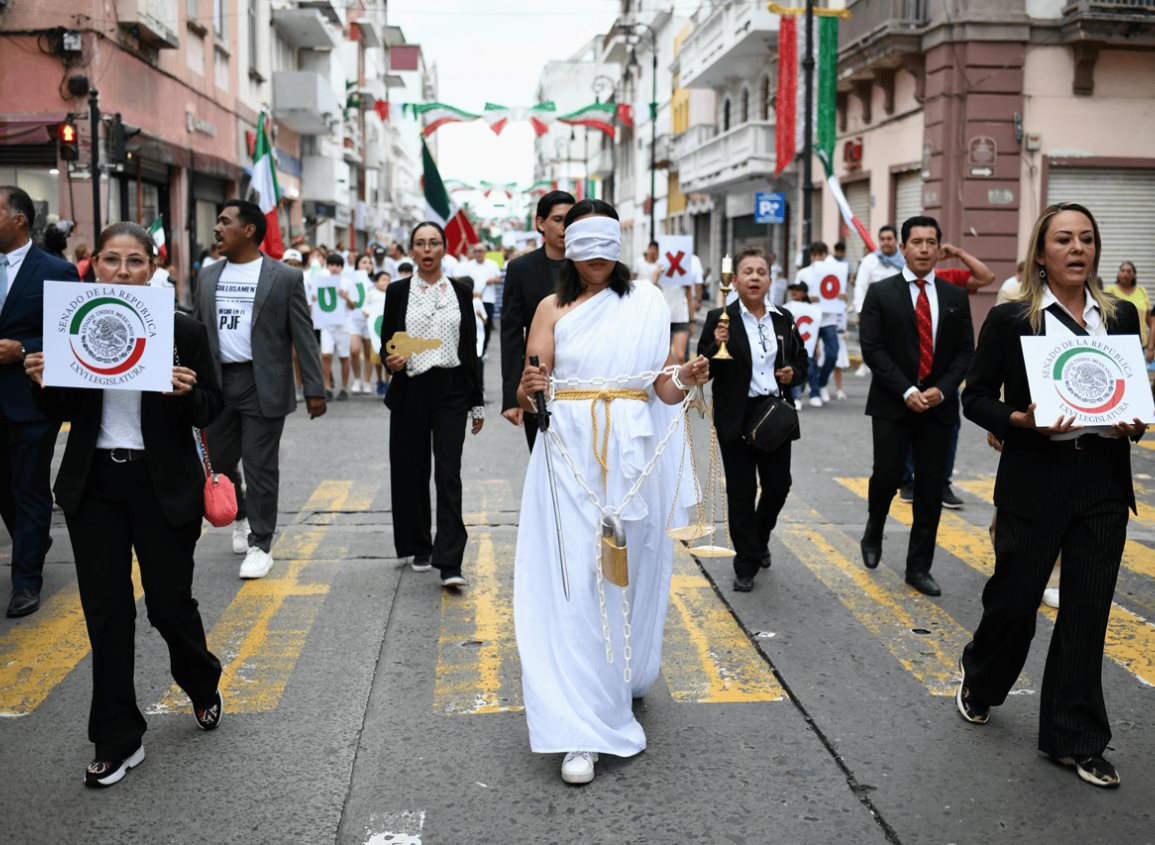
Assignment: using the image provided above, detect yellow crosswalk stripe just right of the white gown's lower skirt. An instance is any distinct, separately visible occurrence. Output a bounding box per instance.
[662,544,787,704]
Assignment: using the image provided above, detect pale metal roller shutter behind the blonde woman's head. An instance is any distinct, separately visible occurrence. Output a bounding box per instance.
[1046,167,1155,290]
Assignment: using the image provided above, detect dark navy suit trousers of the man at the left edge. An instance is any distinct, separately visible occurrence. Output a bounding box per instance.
[0,411,60,590]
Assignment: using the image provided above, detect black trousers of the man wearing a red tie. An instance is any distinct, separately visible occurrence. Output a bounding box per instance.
[867,412,953,573]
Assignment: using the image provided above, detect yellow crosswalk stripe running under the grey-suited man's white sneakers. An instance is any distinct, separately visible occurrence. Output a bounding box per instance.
[149,480,378,713]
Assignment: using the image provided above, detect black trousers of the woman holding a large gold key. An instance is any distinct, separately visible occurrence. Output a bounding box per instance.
[389,367,469,574]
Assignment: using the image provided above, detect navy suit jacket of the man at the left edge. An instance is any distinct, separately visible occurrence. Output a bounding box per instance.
[0,245,80,423]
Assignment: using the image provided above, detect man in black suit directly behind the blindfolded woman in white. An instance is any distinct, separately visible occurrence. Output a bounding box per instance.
[501,190,576,451]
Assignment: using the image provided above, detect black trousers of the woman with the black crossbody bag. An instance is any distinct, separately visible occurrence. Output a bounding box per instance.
[718,422,790,578]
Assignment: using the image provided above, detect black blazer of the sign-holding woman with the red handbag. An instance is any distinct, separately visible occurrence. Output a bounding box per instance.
[32,313,224,525]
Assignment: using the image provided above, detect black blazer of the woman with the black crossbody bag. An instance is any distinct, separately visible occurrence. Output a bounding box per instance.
[698,300,809,441]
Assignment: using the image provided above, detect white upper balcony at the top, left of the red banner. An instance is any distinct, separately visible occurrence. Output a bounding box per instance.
[678,0,778,88]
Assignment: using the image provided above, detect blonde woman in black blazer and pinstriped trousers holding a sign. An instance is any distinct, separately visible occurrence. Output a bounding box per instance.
[955,203,1146,786]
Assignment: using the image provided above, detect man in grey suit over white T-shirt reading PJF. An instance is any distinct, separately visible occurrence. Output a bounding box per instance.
[193,200,326,578]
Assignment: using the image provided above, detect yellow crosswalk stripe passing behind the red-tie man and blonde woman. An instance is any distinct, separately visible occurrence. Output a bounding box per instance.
[837,478,1155,686]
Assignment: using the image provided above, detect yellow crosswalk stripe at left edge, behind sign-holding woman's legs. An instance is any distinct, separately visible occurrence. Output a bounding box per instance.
[0,558,144,717]
